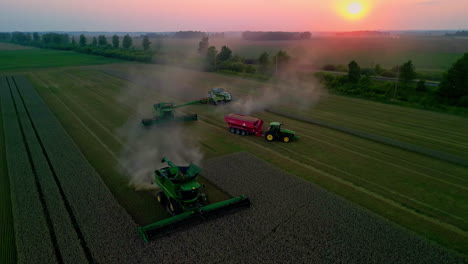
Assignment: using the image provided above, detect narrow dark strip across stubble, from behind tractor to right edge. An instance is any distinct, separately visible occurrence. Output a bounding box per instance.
[268,109,468,167]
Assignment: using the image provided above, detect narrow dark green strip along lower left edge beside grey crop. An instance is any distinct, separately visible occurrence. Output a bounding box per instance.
[0,79,16,264]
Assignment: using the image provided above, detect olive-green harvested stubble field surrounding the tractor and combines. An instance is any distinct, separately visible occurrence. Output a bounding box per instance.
[22,62,468,254]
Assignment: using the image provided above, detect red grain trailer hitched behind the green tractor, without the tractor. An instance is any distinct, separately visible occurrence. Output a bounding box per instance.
[224,113,263,137]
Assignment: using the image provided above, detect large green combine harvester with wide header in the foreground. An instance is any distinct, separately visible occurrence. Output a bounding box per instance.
[138,158,250,243]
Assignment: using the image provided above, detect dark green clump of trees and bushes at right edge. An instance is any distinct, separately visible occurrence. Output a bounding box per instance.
[316,56,468,112]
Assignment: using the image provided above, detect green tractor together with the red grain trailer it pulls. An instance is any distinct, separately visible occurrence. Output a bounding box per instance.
[224,113,299,143]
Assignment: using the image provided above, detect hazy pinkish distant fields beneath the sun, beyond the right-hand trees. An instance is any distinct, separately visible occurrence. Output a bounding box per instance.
[145,37,468,71]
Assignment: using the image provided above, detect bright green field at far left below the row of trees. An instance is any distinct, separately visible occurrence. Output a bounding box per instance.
[0,43,122,71]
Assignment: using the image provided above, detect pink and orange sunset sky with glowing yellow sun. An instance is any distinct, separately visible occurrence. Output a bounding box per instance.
[0,0,468,32]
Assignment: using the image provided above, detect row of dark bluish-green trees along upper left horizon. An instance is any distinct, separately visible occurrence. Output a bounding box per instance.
[0,32,153,62]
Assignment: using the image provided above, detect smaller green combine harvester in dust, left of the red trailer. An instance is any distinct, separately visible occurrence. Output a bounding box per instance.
[141,100,200,127]
